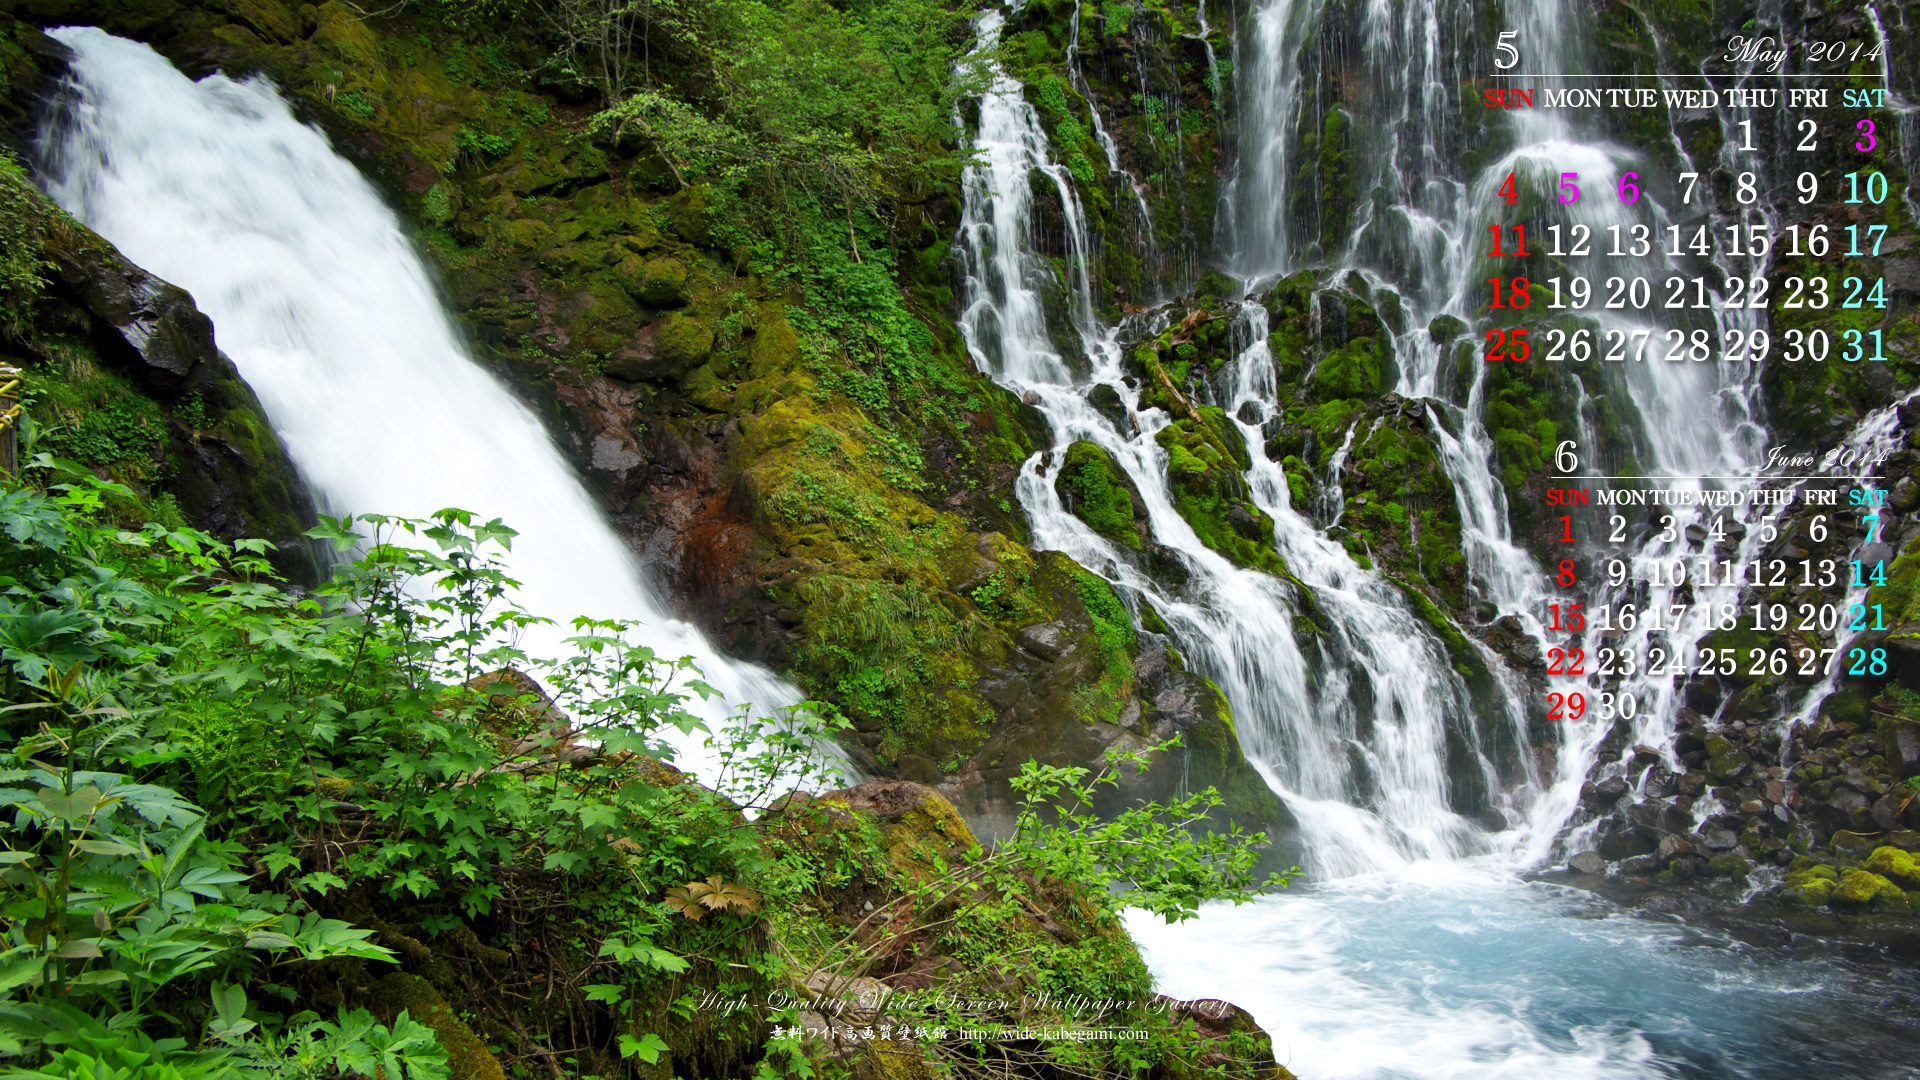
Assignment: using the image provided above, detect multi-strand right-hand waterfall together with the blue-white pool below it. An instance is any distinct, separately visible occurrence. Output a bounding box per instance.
[956,0,1912,1078]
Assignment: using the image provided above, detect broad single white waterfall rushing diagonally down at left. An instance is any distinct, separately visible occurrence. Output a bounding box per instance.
[42,27,801,755]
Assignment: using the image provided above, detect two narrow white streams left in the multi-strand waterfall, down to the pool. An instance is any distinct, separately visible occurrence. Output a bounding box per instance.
[956,12,1519,876]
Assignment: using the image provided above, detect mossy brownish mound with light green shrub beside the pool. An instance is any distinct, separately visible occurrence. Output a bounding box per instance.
[776,740,1298,1076]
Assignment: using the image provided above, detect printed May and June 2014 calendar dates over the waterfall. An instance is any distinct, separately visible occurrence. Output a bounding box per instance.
[1471,38,1896,760]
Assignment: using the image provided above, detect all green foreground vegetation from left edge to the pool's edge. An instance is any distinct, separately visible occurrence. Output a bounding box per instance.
[0,466,1284,1080]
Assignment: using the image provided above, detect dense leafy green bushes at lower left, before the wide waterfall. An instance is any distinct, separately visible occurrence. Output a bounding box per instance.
[0,472,848,1078]
